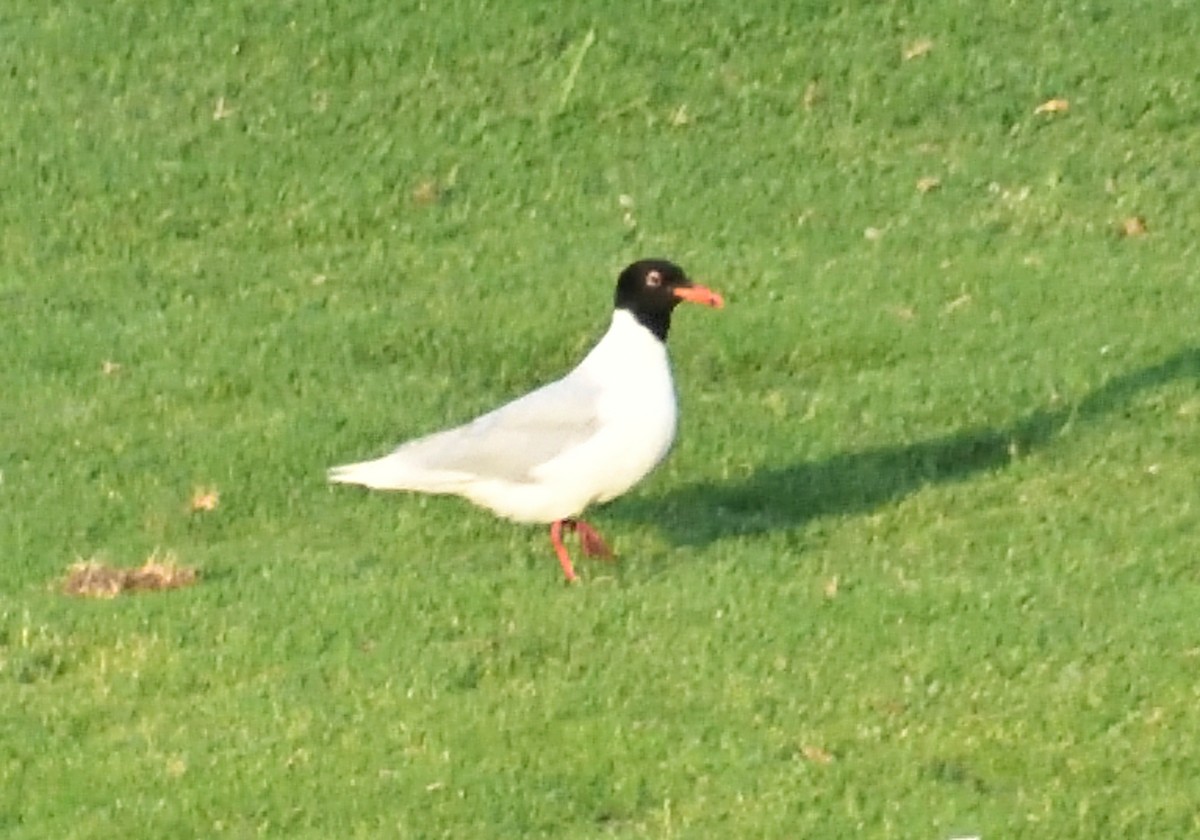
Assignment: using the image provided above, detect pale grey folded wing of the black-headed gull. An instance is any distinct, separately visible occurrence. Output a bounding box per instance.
[396,377,600,484]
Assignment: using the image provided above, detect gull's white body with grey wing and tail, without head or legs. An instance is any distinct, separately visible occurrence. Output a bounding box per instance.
[330,310,677,522]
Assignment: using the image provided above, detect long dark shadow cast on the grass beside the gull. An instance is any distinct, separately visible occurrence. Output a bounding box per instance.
[613,348,1200,545]
